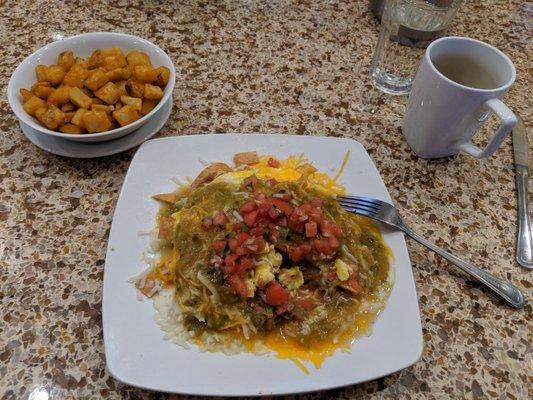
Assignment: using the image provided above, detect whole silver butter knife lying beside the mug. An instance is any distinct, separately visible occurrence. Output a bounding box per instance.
[513,114,533,269]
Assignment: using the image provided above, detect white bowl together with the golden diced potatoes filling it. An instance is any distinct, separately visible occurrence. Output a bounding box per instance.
[8,32,176,142]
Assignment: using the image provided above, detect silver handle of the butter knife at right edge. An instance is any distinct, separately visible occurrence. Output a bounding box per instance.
[515,165,533,269]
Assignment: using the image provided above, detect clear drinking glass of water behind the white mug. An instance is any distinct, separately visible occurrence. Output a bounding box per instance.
[370,0,462,94]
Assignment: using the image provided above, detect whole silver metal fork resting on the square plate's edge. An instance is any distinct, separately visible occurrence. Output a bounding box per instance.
[337,196,525,308]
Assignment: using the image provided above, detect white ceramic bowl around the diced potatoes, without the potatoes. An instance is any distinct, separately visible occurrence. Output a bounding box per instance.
[7,32,176,142]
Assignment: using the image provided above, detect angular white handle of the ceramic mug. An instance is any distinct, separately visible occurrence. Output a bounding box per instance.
[454,99,516,158]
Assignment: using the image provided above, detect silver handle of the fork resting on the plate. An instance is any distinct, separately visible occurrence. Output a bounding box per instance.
[404,227,525,308]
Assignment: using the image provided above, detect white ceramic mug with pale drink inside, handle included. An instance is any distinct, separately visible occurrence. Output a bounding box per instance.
[402,37,516,158]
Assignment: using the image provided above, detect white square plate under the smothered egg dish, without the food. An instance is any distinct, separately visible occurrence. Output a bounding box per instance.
[102,134,423,396]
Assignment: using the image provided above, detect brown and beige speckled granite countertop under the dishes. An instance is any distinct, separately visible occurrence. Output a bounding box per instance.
[0,0,533,400]
